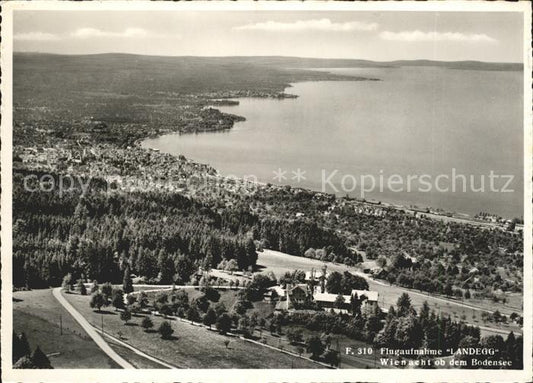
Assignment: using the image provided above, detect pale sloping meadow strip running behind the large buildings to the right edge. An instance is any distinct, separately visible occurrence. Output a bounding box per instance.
[257,250,522,334]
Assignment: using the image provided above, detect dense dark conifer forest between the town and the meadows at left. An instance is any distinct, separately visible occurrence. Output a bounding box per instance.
[13,170,351,288]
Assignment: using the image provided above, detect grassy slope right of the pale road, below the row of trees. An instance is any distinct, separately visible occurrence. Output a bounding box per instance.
[65,294,320,368]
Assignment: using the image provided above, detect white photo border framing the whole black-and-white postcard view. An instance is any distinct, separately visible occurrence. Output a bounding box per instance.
[1,1,533,383]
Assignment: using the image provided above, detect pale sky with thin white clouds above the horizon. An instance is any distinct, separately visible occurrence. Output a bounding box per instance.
[13,10,523,62]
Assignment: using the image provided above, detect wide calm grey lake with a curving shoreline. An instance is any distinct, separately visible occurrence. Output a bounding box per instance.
[143,67,523,218]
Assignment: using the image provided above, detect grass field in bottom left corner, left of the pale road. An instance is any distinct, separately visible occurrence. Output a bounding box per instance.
[13,289,119,369]
